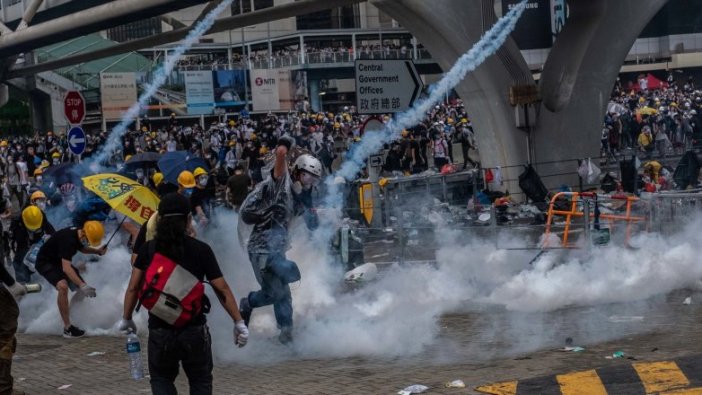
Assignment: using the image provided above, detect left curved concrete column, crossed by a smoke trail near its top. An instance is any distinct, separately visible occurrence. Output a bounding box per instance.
[371,0,533,192]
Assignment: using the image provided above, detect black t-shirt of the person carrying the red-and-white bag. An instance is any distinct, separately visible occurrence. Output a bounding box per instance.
[134,236,222,329]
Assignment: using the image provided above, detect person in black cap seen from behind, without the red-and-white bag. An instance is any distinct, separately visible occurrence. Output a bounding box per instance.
[119,193,249,394]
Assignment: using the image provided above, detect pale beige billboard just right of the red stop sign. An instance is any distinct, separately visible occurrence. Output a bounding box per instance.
[100,73,137,120]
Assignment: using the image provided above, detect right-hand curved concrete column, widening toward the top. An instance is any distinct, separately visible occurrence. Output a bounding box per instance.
[534,0,668,187]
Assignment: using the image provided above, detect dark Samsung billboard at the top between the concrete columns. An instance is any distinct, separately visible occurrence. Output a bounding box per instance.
[502,0,553,49]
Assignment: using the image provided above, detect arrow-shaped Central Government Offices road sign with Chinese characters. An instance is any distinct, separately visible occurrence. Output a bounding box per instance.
[354,60,422,114]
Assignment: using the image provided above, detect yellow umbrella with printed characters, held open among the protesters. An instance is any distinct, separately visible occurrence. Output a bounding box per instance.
[83,173,160,225]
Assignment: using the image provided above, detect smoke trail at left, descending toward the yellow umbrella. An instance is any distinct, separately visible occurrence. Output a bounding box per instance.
[94,0,233,164]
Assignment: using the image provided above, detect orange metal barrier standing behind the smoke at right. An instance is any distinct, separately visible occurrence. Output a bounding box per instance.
[542,192,646,248]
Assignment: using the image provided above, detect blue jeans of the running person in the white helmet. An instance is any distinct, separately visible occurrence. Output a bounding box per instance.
[248,253,292,329]
